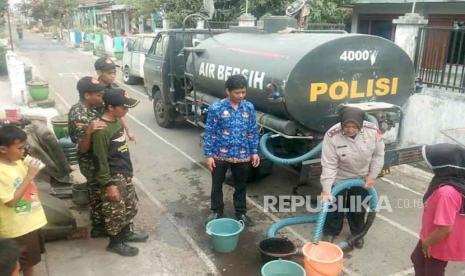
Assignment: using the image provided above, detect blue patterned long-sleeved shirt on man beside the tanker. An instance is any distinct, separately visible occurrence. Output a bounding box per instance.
[204,99,258,163]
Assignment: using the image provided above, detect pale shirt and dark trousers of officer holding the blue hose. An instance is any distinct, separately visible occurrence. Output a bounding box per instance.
[320,121,384,236]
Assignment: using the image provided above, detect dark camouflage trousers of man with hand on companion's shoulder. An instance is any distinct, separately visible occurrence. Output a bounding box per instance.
[79,162,105,227]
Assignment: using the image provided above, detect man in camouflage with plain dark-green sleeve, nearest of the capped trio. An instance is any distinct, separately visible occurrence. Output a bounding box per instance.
[92,88,148,256]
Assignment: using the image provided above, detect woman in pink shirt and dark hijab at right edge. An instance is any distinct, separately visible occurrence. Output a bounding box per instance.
[411,143,465,276]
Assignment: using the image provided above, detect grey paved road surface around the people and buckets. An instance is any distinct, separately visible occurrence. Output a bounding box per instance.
[8,29,465,276]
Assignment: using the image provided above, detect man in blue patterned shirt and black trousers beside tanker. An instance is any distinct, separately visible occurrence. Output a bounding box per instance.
[204,75,260,226]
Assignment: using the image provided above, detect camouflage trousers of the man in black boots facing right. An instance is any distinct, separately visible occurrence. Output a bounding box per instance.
[102,174,139,236]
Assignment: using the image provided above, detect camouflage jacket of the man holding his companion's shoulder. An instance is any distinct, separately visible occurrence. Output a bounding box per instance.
[68,102,103,182]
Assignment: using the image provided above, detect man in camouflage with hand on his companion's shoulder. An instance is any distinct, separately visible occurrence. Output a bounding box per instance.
[68,77,106,238]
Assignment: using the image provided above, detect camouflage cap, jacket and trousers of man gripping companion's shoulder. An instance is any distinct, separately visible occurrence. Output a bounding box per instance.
[68,77,104,232]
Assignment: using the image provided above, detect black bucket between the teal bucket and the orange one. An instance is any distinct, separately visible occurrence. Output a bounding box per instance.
[258,237,296,263]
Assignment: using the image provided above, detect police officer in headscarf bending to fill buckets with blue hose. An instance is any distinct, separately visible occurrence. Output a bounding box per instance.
[320,106,384,248]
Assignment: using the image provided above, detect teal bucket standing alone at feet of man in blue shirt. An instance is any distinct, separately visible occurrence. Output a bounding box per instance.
[207,218,244,253]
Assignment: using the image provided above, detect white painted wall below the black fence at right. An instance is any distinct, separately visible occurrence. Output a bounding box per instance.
[401,88,465,145]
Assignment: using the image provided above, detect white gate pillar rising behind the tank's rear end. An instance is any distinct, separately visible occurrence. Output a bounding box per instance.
[392,13,428,61]
